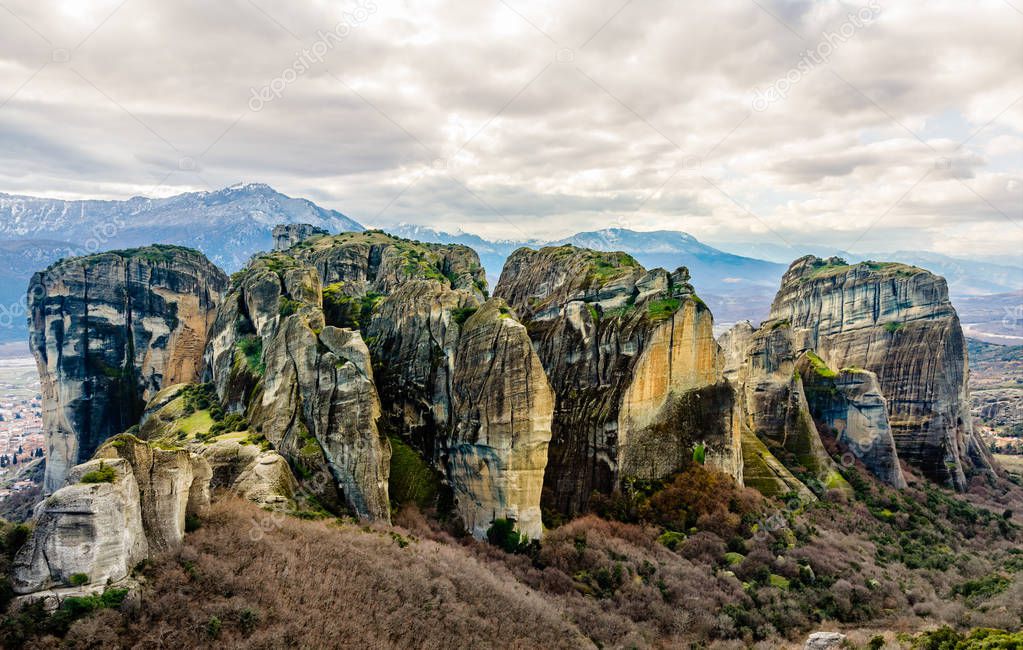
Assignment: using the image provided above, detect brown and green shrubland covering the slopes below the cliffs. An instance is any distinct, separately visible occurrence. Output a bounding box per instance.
[3,464,1023,649]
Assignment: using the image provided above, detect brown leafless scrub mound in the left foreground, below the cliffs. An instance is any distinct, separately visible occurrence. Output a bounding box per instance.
[43,500,588,648]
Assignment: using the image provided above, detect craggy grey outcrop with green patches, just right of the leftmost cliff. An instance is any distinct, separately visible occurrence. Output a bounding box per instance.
[207,253,390,521]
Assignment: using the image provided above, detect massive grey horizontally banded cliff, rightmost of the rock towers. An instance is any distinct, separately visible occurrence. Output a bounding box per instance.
[771,256,990,489]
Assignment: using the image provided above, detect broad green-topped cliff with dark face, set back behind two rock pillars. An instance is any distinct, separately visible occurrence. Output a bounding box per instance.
[288,231,486,458]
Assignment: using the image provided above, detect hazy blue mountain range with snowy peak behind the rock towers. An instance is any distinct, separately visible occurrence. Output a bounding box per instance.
[0,183,1023,341]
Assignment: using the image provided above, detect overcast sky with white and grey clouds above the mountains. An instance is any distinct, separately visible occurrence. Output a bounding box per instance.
[0,0,1023,256]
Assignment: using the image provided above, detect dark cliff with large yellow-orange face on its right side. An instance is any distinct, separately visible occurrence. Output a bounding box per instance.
[494,246,742,513]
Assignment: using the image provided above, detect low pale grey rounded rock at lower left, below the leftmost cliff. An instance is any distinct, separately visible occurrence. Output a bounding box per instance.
[11,460,149,594]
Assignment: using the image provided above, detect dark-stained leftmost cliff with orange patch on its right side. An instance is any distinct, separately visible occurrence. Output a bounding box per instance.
[29,246,228,492]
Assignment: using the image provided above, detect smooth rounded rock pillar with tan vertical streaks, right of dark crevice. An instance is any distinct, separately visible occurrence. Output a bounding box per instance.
[446,299,554,538]
